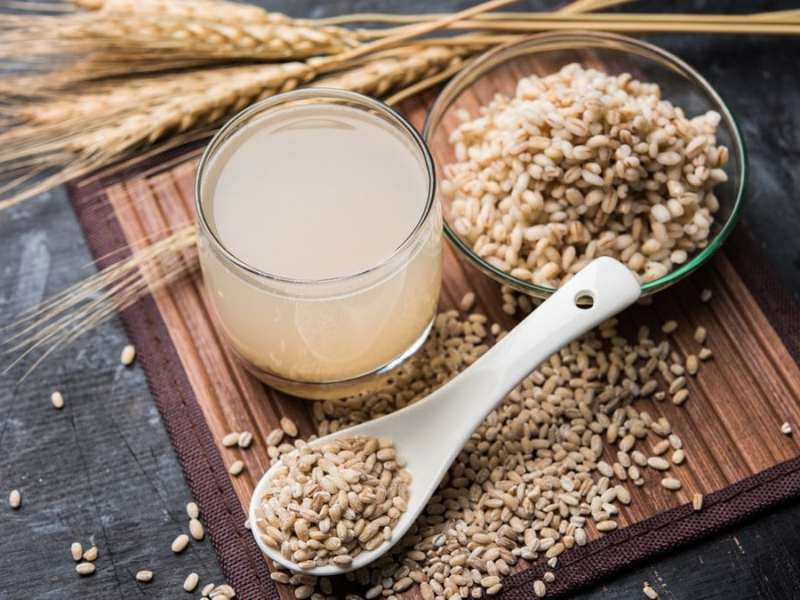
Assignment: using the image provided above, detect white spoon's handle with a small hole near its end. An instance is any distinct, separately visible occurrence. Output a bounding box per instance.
[426,257,641,448]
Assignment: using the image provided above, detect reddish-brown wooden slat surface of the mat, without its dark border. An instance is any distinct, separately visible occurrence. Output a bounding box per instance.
[95,90,800,598]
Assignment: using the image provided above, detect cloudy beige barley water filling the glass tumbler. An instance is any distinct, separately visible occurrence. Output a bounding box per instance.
[201,105,441,392]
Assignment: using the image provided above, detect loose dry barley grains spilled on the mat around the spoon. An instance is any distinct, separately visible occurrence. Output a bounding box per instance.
[273,304,705,600]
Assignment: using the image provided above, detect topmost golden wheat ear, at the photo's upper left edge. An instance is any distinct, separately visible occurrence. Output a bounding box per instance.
[0,3,358,76]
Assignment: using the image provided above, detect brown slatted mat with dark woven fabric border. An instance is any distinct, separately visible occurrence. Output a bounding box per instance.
[67,105,800,600]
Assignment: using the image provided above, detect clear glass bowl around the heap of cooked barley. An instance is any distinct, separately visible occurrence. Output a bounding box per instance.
[423,31,748,298]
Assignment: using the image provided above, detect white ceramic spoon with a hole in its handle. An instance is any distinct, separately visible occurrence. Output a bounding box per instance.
[249,257,640,576]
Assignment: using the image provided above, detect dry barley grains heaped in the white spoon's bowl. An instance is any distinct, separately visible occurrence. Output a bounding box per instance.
[256,437,411,569]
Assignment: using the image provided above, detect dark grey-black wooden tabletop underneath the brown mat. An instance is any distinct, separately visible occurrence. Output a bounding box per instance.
[0,0,800,600]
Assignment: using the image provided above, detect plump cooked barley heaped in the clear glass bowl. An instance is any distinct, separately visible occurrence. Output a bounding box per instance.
[442,64,728,287]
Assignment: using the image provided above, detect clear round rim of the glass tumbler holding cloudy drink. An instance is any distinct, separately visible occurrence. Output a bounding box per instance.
[194,87,436,286]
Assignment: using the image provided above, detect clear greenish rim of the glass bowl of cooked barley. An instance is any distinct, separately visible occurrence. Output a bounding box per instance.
[422,29,750,298]
